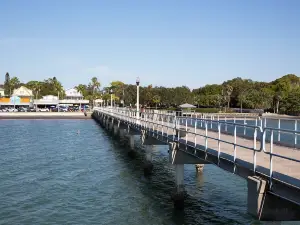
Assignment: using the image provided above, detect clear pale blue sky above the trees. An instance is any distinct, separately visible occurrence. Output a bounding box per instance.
[0,0,300,88]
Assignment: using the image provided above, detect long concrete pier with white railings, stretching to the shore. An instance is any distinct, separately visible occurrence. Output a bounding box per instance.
[92,108,300,221]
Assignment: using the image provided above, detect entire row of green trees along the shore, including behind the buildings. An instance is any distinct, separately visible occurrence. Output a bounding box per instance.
[4,73,300,115]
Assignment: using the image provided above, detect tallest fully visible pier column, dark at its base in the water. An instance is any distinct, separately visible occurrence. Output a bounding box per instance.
[172,164,185,209]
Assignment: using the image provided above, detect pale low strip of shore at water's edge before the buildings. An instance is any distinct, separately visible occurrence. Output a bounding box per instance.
[0,112,92,120]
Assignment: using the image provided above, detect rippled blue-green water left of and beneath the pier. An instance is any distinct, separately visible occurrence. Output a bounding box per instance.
[0,119,296,225]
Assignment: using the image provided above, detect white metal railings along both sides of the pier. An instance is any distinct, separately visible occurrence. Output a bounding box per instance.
[96,108,300,189]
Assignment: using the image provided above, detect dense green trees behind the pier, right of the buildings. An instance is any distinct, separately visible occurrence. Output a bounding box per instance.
[98,74,300,115]
